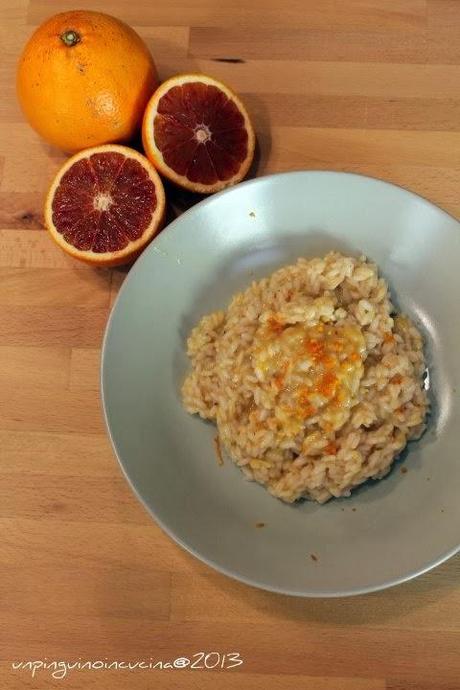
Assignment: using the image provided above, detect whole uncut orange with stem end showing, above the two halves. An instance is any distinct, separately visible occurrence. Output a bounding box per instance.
[17,10,158,152]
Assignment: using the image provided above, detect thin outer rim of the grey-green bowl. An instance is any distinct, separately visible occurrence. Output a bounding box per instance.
[99,168,460,599]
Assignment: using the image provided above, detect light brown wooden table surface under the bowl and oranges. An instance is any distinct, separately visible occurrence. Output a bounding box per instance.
[0,0,460,690]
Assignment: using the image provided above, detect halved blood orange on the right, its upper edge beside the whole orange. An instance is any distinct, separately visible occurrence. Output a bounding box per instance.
[142,74,255,194]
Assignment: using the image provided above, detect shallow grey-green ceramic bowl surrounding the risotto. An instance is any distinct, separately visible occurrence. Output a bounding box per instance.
[102,172,460,596]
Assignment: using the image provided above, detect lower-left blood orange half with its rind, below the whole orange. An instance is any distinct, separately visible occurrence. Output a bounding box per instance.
[45,144,165,266]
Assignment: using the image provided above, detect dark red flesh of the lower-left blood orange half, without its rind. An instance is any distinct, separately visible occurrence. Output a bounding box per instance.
[52,151,157,253]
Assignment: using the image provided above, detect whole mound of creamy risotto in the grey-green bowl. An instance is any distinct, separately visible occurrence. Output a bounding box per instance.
[182,252,428,503]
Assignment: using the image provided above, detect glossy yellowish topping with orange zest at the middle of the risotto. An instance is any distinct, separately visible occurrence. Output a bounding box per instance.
[253,319,365,433]
